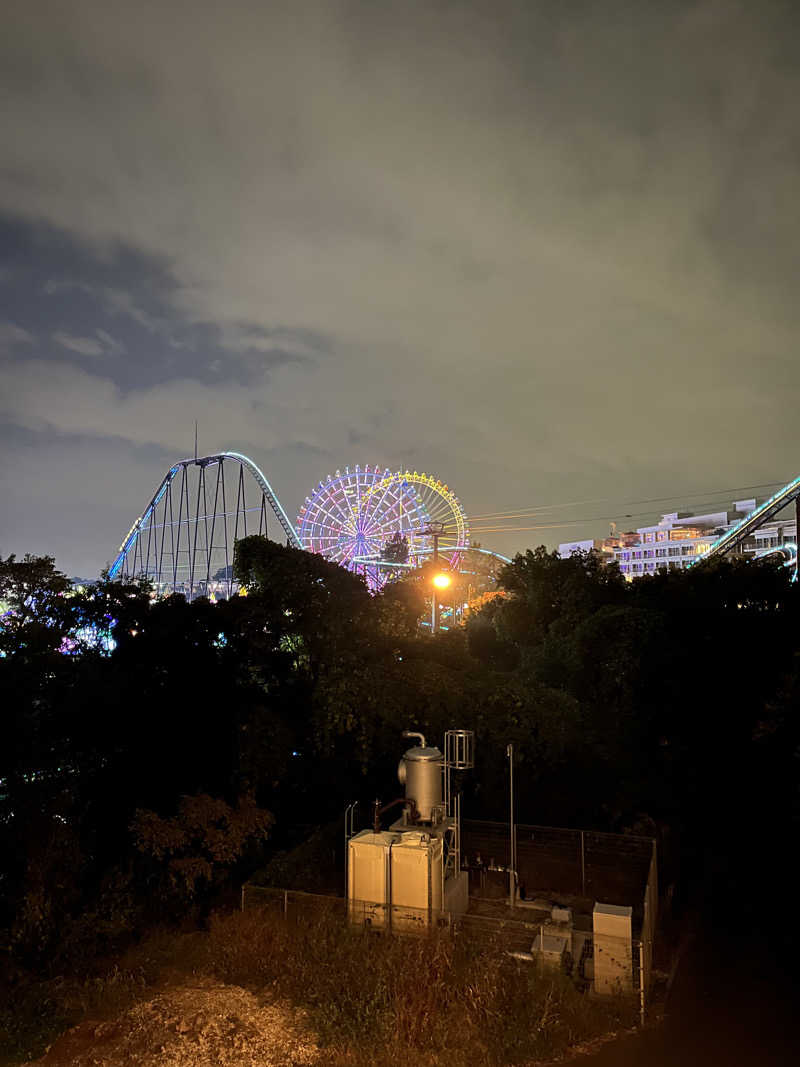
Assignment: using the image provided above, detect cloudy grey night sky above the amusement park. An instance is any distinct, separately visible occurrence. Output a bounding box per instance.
[0,0,800,575]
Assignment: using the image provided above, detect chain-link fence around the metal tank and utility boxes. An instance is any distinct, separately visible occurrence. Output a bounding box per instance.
[241,819,658,1020]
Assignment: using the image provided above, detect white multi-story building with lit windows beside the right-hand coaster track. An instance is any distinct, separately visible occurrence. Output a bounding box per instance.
[558,499,797,578]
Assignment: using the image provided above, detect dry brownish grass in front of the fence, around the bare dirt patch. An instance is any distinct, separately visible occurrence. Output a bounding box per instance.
[0,911,636,1067]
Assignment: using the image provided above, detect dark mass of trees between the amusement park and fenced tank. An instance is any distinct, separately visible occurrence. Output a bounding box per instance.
[0,537,800,981]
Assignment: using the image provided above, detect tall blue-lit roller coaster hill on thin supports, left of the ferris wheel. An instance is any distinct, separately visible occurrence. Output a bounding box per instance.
[109,452,302,600]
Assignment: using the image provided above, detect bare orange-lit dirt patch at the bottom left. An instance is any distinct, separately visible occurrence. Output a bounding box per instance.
[28,980,319,1067]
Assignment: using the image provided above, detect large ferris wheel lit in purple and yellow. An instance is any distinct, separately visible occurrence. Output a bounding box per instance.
[297,465,469,588]
